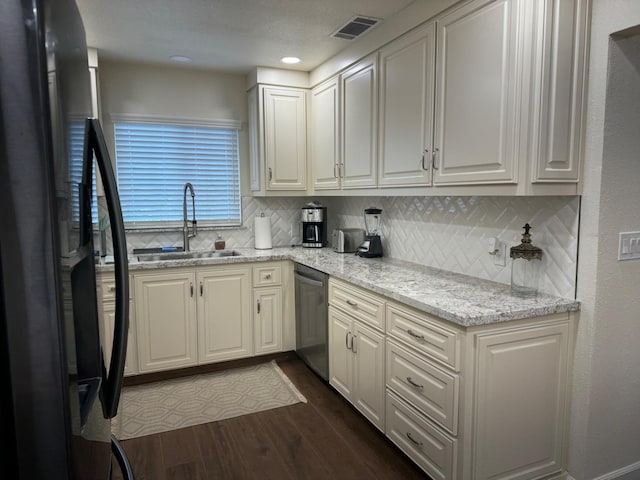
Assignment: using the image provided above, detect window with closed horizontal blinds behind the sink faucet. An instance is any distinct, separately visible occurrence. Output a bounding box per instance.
[114,120,241,228]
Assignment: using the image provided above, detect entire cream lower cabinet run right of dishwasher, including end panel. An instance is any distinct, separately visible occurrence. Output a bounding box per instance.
[329,278,575,480]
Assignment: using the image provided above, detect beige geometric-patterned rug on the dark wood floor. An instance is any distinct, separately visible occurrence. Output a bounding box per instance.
[111,361,307,440]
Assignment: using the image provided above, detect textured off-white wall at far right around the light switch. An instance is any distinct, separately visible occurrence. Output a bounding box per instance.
[569,0,640,480]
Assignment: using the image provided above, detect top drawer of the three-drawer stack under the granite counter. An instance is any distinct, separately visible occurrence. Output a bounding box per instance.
[387,303,462,371]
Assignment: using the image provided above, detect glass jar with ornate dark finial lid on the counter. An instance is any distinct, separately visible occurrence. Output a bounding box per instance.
[510,223,542,297]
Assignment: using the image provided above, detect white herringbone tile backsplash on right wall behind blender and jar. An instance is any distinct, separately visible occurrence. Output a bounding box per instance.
[323,196,580,298]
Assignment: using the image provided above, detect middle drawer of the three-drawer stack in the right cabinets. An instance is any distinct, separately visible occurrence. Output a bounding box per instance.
[386,340,459,435]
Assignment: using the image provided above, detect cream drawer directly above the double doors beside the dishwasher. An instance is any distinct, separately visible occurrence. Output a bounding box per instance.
[329,279,385,330]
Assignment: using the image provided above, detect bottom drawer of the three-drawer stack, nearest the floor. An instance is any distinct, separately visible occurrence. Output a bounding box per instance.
[385,391,458,480]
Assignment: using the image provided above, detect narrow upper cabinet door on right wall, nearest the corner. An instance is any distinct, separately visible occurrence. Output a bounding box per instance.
[310,77,340,190]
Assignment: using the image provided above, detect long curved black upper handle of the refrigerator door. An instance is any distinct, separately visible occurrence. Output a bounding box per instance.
[85,118,129,418]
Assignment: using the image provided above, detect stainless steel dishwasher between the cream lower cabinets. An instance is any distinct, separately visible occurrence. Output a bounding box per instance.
[294,263,329,381]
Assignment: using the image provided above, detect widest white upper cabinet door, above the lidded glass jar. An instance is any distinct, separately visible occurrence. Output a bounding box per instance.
[433,0,521,185]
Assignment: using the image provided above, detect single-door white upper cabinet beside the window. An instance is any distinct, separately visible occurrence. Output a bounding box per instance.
[248,85,307,193]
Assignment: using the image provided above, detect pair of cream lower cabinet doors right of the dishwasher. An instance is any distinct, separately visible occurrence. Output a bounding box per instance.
[329,306,384,430]
